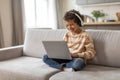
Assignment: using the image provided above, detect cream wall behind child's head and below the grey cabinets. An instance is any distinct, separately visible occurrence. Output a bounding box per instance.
[60,0,120,28]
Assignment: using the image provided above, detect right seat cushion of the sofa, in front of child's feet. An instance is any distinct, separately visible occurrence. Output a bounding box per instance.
[49,65,120,80]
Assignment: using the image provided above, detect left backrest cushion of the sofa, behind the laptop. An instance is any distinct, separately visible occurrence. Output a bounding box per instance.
[23,28,66,58]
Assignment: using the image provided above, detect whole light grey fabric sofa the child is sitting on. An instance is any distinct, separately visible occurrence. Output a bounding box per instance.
[0,28,120,80]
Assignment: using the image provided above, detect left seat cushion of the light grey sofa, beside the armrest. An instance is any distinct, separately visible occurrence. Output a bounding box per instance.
[0,57,59,80]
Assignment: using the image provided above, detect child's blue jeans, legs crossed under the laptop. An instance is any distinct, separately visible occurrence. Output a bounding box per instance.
[43,55,86,71]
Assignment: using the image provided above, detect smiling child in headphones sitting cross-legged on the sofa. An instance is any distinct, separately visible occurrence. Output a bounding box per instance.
[43,10,95,71]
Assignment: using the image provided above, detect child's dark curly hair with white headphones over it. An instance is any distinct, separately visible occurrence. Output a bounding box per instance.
[63,9,84,27]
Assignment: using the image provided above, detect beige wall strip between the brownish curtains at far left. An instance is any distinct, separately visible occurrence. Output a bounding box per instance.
[0,0,12,47]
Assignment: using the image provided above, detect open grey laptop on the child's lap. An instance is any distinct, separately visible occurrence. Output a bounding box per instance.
[42,41,72,60]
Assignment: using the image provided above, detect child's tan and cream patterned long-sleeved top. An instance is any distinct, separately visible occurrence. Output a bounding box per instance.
[64,29,96,60]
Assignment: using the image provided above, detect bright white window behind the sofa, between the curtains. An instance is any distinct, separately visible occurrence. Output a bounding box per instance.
[24,0,51,28]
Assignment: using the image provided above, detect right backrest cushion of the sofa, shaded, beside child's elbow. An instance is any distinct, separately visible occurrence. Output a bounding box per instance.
[87,30,120,67]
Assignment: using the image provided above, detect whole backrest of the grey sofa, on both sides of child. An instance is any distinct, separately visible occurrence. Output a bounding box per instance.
[23,29,120,67]
